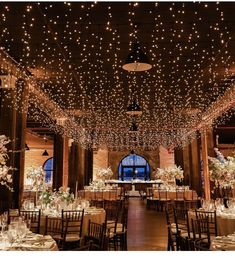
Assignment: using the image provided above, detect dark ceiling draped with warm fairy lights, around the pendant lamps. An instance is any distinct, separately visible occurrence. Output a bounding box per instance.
[0,2,235,149]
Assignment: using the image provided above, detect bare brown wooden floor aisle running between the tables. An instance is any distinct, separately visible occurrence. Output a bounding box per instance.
[127,198,167,251]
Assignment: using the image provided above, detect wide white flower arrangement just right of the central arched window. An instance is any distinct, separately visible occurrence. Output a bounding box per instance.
[155,165,184,182]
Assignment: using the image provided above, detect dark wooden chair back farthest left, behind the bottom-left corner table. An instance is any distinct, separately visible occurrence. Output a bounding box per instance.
[19,210,41,234]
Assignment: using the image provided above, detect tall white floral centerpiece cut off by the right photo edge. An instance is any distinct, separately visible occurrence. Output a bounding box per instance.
[208,148,235,188]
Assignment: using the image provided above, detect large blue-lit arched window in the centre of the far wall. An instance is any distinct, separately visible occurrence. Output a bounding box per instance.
[118,154,150,181]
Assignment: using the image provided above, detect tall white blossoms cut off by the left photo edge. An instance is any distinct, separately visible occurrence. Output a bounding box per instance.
[0,135,15,192]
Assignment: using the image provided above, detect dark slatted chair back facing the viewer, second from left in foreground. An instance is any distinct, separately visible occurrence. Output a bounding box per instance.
[62,209,84,237]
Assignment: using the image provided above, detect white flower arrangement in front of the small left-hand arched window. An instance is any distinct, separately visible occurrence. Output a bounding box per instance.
[27,166,47,191]
